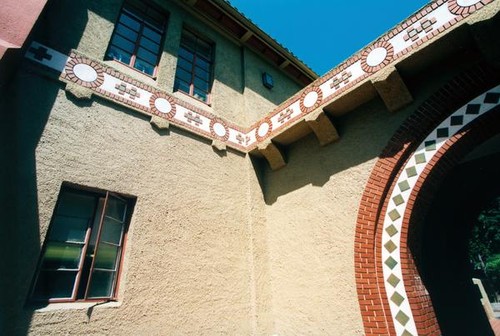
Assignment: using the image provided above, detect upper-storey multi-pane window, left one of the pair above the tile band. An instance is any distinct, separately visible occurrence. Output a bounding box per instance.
[106,0,167,76]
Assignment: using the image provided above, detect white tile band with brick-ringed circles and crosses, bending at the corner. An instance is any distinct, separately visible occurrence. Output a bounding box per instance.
[26,0,496,153]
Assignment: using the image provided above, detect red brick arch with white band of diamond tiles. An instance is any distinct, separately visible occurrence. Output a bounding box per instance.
[354,66,500,336]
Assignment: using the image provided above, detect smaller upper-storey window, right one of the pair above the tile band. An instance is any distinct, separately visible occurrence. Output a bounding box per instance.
[174,30,214,103]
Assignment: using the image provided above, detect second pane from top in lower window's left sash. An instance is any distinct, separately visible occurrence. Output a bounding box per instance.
[50,216,89,243]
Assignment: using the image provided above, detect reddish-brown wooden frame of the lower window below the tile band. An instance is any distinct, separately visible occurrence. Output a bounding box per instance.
[30,182,136,303]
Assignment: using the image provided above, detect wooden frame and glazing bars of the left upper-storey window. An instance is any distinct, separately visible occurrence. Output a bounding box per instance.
[104,0,169,78]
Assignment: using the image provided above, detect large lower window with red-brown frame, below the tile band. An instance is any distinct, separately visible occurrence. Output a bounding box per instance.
[32,184,134,302]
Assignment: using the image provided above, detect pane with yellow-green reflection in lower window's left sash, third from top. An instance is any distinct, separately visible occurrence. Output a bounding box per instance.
[42,242,82,269]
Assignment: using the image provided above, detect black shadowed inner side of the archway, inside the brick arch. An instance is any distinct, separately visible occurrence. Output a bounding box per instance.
[409,153,500,336]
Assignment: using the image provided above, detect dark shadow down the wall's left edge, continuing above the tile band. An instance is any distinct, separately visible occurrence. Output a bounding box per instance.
[0,0,97,335]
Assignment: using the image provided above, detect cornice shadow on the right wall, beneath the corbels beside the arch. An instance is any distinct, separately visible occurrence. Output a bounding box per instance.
[254,98,414,205]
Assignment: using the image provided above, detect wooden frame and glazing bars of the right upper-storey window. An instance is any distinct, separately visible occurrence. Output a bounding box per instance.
[174,28,215,105]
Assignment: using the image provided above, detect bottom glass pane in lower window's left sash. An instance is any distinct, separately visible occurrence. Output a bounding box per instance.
[33,271,77,300]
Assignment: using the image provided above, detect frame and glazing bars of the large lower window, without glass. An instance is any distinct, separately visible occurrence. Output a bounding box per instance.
[28,182,136,303]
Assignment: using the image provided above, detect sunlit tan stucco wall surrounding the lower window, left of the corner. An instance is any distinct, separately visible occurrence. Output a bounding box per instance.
[1,67,270,335]
